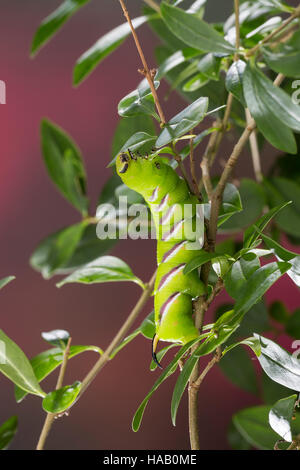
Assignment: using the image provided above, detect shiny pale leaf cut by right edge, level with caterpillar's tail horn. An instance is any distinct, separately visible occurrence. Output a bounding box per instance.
[254,334,300,391]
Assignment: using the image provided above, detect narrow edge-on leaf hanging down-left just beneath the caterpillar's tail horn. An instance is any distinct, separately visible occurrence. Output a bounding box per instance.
[132,338,198,432]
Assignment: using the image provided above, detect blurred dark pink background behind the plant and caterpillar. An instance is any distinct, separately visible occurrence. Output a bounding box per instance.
[0,0,297,449]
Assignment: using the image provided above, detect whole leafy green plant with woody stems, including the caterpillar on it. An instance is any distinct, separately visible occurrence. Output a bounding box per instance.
[0,0,300,450]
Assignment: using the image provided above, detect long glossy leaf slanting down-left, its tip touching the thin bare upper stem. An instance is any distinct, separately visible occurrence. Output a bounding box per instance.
[73,16,147,86]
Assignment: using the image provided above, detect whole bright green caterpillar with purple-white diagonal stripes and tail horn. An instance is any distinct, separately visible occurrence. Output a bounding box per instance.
[116,151,205,366]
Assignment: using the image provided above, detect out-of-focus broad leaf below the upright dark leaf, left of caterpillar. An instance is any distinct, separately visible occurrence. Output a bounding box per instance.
[30,222,87,279]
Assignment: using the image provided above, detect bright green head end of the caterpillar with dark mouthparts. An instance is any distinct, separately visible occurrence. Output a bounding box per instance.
[116,150,166,192]
